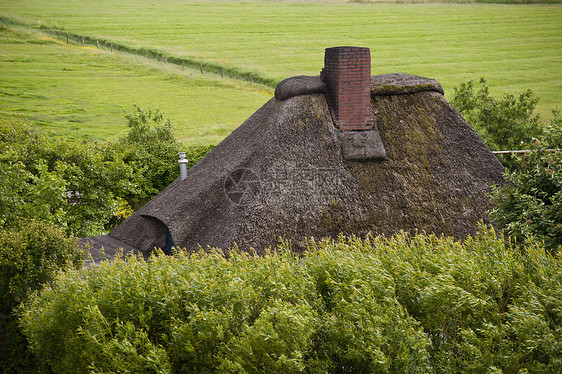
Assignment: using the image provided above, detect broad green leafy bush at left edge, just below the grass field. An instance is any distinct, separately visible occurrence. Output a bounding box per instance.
[0,121,138,236]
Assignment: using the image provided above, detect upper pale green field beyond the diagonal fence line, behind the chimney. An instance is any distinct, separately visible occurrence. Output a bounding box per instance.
[0,0,562,114]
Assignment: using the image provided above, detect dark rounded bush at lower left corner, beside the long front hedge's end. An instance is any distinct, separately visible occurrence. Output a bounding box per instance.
[0,221,84,373]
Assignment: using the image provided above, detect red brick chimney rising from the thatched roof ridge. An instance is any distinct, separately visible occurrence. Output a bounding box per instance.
[320,47,375,130]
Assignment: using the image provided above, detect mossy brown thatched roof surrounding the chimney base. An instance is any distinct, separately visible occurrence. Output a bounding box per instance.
[109,74,503,252]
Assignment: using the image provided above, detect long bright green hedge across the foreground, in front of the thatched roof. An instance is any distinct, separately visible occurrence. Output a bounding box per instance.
[22,229,562,373]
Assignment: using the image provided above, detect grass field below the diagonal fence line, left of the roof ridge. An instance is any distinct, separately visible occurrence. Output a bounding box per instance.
[0,26,271,145]
